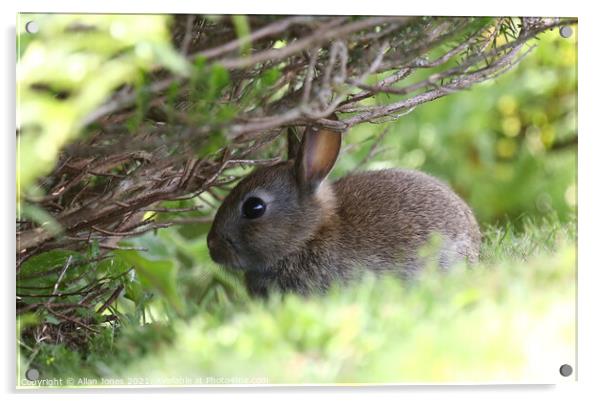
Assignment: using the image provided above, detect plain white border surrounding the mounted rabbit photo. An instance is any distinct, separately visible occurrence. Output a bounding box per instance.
[0,0,602,401]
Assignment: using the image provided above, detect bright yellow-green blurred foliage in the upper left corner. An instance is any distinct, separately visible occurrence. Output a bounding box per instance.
[17,14,188,197]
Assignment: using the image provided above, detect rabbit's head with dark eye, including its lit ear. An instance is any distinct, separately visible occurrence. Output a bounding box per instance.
[207,126,341,271]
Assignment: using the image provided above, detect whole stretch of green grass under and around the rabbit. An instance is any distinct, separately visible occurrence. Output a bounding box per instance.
[20,219,576,384]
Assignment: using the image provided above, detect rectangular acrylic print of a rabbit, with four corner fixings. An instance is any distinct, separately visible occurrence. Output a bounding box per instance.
[16,14,577,388]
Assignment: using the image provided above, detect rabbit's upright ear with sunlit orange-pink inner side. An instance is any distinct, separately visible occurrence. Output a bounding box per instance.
[295,126,341,193]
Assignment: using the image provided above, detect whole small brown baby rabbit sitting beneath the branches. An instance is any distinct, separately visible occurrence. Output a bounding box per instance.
[207,126,481,296]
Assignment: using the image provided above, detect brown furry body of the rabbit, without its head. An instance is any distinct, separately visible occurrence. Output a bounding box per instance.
[240,169,480,294]
